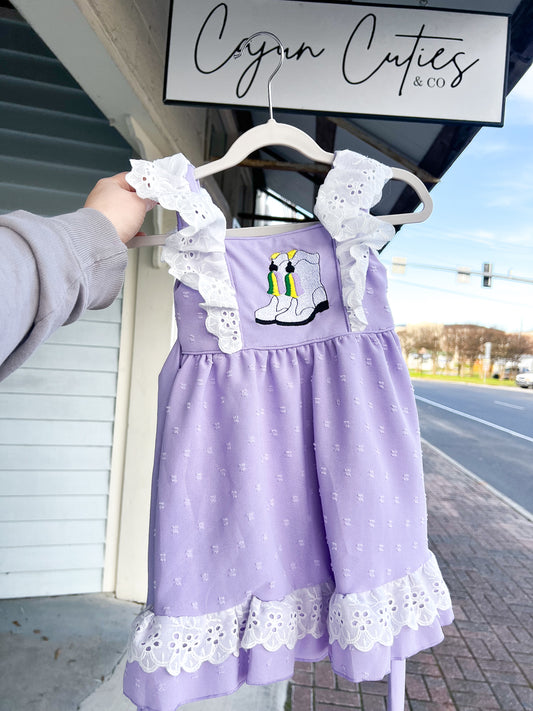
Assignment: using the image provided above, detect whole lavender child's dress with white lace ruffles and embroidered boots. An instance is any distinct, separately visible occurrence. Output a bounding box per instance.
[124,151,452,711]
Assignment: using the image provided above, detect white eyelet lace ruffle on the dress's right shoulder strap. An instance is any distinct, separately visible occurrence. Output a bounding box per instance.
[315,151,395,331]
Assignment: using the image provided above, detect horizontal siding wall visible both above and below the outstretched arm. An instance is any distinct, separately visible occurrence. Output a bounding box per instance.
[0,13,131,597]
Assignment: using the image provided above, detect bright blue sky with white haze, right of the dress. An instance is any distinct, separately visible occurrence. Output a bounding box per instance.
[381,71,533,331]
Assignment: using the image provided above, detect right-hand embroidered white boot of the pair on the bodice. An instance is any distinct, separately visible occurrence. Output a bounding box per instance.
[276,249,329,326]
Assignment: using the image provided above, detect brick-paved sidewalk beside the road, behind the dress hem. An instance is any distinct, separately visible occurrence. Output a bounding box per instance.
[286,446,533,711]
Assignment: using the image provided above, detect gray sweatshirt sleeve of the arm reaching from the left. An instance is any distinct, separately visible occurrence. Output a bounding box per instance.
[0,208,127,380]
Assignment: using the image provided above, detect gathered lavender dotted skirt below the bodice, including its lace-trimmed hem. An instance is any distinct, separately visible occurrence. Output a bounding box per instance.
[124,329,452,711]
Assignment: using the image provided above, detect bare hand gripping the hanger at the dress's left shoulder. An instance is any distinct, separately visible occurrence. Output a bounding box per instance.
[84,173,156,244]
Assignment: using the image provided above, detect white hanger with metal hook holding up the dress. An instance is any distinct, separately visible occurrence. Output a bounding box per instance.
[128,31,433,247]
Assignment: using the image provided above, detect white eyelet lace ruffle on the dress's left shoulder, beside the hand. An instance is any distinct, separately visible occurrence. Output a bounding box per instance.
[126,153,242,353]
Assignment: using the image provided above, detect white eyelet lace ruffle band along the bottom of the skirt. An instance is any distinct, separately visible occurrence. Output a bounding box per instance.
[128,554,451,676]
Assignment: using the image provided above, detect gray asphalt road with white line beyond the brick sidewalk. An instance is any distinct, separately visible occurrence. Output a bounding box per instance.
[413,379,533,513]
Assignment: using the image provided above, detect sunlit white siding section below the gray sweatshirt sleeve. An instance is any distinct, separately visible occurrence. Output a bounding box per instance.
[0,300,121,597]
